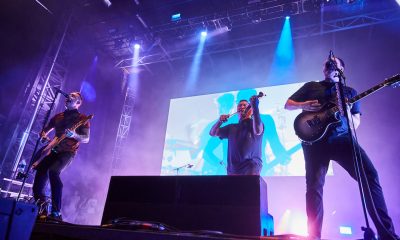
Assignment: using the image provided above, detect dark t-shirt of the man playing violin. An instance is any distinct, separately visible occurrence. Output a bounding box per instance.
[219,119,264,174]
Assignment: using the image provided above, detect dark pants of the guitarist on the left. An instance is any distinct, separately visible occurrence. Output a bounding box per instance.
[33,152,75,211]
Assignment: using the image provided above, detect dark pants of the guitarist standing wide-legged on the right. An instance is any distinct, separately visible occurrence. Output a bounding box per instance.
[303,138,394,239]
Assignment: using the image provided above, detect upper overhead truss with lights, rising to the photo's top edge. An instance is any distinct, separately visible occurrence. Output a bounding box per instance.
[92,0,314,60]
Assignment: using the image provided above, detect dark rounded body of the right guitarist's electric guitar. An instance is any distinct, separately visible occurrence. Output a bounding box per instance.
[294,102,340,143]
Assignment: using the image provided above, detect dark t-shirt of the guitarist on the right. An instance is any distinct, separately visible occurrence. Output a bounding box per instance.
[289,80,361,137]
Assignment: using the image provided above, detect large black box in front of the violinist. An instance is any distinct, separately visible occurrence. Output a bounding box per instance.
[102,176,274,236]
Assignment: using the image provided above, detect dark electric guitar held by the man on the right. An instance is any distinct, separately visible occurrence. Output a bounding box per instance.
[294,74,400,143]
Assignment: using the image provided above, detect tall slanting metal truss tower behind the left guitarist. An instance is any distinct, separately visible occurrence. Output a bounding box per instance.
[0,14,74,189]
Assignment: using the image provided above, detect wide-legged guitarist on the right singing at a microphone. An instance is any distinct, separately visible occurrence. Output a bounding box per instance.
[285,58,399,239]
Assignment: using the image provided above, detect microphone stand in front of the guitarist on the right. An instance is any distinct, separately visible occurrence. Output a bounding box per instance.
[329,52,395,240]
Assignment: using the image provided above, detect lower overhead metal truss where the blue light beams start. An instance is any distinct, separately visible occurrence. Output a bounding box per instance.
[116,9,400,69]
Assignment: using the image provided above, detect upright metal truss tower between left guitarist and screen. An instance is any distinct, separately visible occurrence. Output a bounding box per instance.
[112,76,135,170]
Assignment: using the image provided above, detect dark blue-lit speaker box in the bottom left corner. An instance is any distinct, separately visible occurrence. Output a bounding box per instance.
[0,198,38,240]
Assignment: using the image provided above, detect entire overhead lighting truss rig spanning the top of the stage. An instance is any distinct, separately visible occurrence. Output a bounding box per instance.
[86,0,400,72]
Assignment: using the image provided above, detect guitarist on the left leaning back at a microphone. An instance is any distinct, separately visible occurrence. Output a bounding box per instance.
[33,92,89,220]
